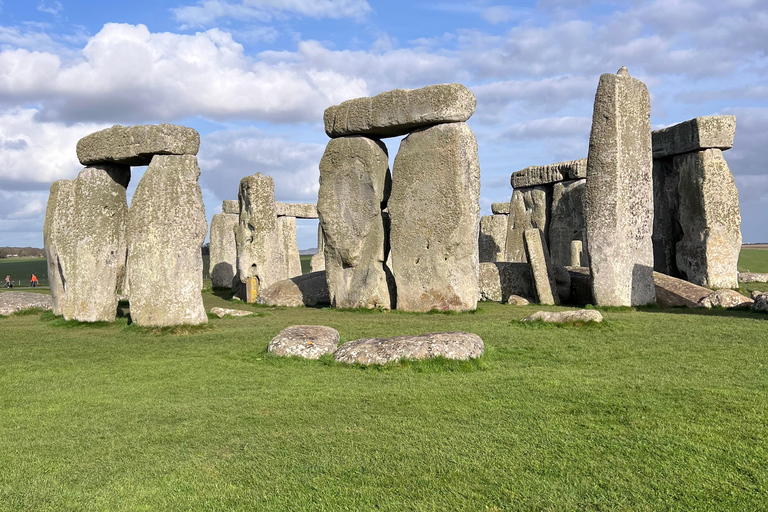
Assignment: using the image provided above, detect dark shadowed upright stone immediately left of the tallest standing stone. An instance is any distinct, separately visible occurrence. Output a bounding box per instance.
[548,179,589,266]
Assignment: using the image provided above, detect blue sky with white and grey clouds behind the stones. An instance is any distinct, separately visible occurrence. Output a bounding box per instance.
[0,0,768,248]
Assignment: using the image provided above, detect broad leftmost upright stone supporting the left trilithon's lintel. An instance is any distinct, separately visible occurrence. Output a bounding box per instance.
[43,164,131,322]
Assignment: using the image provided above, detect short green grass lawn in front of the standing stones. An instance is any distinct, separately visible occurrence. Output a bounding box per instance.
[0,293,768,511]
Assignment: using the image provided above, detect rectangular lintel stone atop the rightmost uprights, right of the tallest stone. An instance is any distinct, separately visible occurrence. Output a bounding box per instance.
[653,116,736,158]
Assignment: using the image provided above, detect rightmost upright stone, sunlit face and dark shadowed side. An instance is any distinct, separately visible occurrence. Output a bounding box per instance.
[673,149,741,288]
